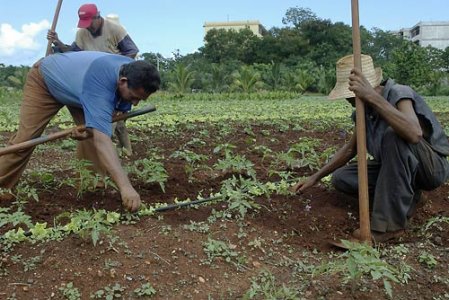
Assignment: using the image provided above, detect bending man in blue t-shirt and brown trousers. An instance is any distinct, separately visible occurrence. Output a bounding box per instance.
[0,51,160,211]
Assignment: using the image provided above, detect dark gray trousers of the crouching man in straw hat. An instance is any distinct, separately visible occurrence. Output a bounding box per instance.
[332,128,449,232]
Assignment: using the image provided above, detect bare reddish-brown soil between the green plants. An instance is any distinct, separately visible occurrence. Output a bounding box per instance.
[0,125,449,299]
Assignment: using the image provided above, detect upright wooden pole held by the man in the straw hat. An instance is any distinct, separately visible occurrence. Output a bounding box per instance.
[351,0,371,244]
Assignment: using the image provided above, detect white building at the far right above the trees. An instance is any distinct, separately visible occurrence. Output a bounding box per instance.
[398,22,449,50]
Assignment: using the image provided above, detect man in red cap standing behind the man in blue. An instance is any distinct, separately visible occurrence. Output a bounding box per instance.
[47,4,139,155]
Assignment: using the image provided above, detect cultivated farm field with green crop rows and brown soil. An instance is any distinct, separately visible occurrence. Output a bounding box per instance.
[0,93,449,299]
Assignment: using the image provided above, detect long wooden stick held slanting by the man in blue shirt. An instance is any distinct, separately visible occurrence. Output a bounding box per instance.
[0,105,156,156]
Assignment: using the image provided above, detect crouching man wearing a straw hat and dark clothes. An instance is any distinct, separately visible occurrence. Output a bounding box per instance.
[293,55,449,242]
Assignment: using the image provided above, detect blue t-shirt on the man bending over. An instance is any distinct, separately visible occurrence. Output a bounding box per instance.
[40,51,133,136]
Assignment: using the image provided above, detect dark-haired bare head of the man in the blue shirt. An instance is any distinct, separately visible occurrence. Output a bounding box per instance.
[117,60,161,105]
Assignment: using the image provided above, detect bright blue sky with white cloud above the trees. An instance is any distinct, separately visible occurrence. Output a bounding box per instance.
[0,0,449,66]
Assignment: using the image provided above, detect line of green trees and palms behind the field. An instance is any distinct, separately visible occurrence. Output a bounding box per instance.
[0,7,449,95]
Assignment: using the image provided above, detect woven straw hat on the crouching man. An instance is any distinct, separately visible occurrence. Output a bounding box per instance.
[328,54,382,100]
